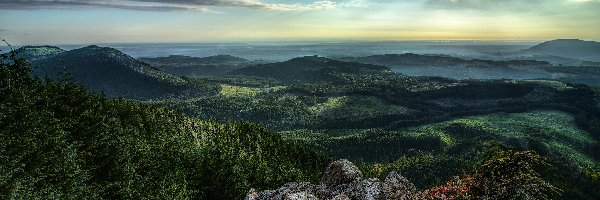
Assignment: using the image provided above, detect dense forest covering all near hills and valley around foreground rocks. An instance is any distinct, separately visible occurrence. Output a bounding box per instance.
[0,46,600,199]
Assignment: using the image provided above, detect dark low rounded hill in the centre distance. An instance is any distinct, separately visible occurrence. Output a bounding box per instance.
[227,56,391,82]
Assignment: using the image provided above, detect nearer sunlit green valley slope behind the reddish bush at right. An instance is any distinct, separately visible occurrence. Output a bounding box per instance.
[314,111,600,199]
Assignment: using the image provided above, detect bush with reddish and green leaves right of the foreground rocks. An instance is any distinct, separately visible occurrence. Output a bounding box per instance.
[420,149,572,199]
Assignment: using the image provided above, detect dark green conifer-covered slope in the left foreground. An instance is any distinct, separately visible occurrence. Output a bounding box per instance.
[0,47,330,199]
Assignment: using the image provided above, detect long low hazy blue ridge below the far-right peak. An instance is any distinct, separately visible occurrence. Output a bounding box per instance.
[337,53,600,85]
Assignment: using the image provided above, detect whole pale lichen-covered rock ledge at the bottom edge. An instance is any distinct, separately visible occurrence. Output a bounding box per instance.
[246,160,417,200]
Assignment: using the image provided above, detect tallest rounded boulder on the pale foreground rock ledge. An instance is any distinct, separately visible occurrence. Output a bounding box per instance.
[321,159,362,186]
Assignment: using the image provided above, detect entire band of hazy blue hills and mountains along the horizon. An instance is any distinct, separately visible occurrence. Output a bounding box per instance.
[8,40,600,99]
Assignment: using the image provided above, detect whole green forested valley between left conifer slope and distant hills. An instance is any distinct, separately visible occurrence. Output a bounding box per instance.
[150,66,600,198]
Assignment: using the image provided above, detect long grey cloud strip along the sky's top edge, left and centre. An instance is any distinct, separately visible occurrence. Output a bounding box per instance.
[0,0,362,12]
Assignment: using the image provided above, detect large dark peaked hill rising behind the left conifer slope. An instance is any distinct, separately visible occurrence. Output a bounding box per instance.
[20,46,209,99]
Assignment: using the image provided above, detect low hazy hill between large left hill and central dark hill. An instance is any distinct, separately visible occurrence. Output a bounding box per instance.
[138,55,257,76]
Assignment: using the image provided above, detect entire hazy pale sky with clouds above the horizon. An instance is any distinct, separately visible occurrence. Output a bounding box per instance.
[0,0,600,44]
